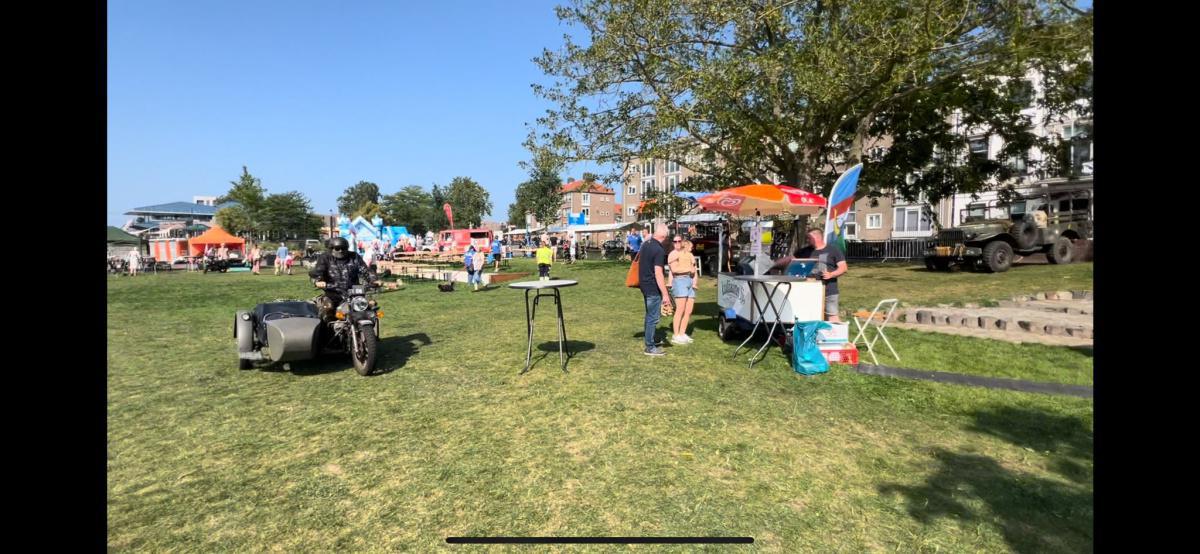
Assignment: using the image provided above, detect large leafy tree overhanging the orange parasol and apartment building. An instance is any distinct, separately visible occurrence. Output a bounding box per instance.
[526,0,1092,201]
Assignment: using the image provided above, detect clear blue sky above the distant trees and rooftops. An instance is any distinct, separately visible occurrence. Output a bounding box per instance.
[107,0,596,225]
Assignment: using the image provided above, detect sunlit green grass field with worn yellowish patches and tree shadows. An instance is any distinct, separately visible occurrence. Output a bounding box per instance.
[108,260,1093,552]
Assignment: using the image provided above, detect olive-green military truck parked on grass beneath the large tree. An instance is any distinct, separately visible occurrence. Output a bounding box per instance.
[925,188,1092,273]
